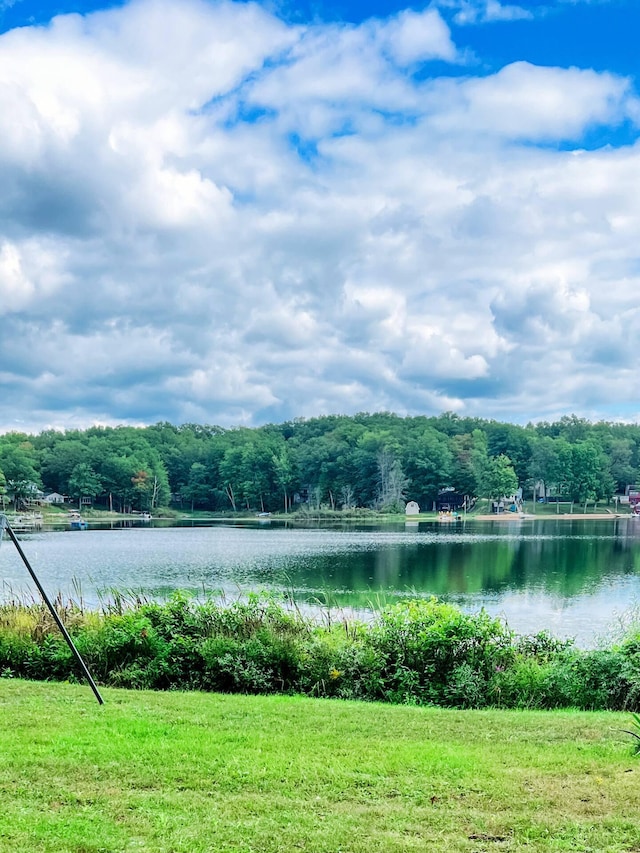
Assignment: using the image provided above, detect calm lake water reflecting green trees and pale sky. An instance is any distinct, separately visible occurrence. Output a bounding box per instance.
[0,518,640,645]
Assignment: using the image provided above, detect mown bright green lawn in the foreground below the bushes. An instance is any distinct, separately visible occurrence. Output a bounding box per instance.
[0,679,640,853]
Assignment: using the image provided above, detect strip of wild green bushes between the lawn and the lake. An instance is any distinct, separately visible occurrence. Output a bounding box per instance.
[0,594,640,711]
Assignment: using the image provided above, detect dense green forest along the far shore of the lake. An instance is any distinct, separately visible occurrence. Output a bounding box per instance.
[0,413,640,512]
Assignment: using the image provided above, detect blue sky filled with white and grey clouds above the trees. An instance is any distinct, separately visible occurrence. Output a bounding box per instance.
[0,0,640,432]
